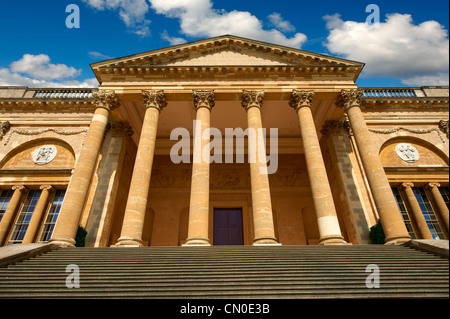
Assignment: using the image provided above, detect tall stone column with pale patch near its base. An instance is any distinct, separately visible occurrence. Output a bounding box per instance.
[290,90,346,245]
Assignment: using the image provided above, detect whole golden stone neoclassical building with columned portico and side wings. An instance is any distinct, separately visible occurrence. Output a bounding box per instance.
[0,36,449,247]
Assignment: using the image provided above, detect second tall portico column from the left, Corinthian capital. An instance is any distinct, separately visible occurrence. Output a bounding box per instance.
[115,91,167,247]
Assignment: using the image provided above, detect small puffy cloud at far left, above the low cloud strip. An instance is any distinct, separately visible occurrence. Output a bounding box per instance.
[11,54,81,80]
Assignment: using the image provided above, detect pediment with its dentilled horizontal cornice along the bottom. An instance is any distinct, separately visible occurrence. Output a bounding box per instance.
[91,36,364,82]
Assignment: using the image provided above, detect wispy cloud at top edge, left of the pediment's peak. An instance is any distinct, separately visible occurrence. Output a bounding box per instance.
[83,0,150,37]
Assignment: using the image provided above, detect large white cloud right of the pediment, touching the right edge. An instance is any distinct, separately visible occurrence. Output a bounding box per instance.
[324,13,449,85]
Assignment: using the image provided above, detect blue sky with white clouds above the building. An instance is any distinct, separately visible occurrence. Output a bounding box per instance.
[0,0,449,87]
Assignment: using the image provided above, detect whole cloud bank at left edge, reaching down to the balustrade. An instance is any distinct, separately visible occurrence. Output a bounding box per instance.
[0,54,98,88]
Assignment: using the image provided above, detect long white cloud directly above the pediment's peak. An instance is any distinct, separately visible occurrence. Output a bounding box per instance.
[149,0,307,48]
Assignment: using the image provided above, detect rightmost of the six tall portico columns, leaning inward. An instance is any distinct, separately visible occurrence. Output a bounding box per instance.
[338,90,411,245]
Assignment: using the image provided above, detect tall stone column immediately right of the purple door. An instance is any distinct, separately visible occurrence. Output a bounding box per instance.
[242,90,280,245]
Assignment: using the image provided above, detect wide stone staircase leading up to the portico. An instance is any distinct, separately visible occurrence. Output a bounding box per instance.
[0,245,449,299]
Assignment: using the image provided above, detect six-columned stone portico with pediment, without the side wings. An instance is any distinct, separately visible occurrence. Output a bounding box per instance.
[13,36,436,247]
